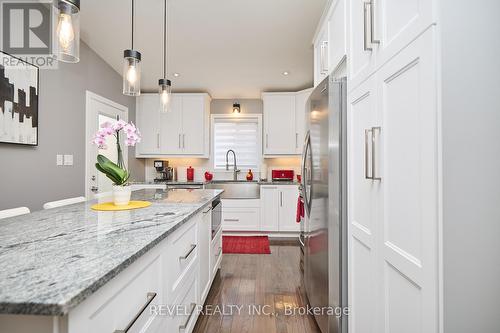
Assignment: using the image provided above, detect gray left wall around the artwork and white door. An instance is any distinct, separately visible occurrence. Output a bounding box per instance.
[0,43,144,210]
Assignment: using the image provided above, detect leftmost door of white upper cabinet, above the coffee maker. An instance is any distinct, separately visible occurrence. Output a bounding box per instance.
[136,94,160,155]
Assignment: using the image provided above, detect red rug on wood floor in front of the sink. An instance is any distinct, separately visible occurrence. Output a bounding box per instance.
[222,236,271,254]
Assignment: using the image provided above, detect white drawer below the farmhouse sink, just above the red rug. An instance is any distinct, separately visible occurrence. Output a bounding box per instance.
[222,207,260,231]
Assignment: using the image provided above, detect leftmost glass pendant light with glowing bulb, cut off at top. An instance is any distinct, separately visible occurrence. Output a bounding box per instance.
[54,0,80,63]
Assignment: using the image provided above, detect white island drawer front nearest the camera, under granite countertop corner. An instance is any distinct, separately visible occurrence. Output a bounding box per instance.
[68,250,163,333]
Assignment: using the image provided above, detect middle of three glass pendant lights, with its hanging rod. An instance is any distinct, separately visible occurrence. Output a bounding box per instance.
[123,0,141,96]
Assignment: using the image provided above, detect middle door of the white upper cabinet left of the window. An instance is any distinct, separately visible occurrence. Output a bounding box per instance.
[160,94,182,155]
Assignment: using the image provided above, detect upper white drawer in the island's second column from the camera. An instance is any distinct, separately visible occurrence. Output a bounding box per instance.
[165,215,201,294]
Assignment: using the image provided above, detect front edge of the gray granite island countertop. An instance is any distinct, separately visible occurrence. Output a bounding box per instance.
[0,191,223,316]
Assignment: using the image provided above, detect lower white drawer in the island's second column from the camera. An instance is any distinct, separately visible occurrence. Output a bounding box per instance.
[164,272,198,333]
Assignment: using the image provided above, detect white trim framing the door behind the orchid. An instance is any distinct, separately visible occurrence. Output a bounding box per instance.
[84,90,128,199]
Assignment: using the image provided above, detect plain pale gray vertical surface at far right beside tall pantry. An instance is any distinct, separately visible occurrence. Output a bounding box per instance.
[439,0,500,333]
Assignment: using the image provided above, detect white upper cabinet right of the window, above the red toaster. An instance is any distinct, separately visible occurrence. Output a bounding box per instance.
[262,89,311,156]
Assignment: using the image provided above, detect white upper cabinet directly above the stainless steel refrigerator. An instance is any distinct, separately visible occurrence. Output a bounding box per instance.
[314,0,347,86]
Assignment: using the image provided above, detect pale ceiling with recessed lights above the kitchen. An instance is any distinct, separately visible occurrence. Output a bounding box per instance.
[80,0,327,98]
